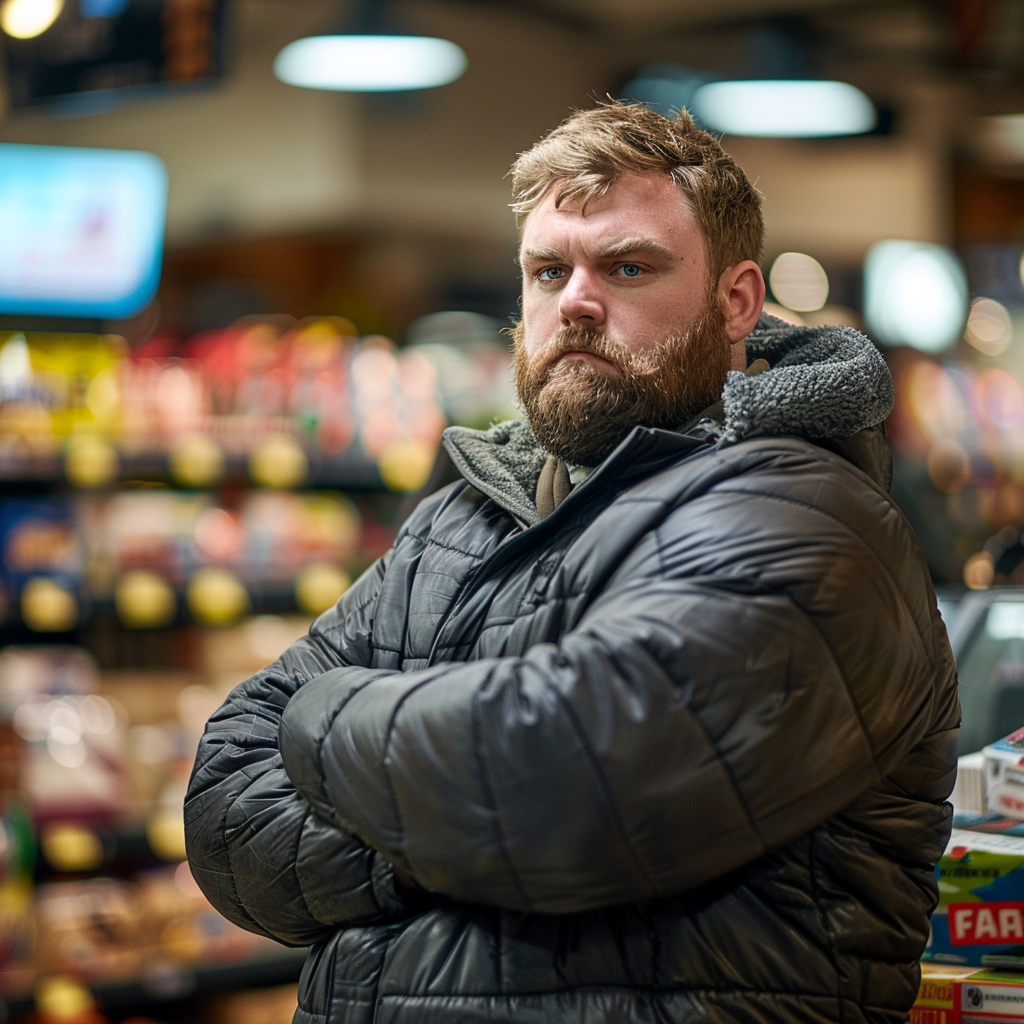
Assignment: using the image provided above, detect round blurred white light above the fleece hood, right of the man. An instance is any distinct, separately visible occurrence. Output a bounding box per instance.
[864,241,968,352]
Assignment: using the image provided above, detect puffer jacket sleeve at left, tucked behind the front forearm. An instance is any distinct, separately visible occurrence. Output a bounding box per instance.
[185,559,421,945]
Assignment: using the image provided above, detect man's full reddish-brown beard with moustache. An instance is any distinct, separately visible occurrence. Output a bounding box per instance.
[512,297,730,466]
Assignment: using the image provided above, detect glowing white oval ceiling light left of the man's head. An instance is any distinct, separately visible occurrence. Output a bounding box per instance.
[273,36,467,92]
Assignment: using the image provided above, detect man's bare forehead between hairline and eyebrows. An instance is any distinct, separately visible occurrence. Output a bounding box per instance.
[520,174,703,256]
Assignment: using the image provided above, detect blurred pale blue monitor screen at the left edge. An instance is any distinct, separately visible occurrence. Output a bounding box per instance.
[0,144,167,319]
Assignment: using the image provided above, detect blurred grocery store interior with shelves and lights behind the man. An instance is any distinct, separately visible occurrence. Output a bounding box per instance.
[0,0,1024,1024]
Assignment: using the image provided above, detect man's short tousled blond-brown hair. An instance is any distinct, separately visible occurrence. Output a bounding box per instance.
[510,101,764,282]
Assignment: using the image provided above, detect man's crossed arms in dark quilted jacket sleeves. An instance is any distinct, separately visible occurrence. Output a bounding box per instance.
[185,471,931,944]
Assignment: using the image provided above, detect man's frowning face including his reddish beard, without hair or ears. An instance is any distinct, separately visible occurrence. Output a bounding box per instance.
[515,175,730,466]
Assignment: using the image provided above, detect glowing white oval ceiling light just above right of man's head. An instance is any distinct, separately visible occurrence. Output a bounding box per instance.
[693,79,878,138]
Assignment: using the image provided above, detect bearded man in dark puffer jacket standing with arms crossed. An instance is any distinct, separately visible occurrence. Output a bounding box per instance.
[185,104,959,1024]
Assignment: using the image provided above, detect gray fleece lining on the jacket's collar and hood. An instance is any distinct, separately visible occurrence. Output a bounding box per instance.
[443,313,893,523]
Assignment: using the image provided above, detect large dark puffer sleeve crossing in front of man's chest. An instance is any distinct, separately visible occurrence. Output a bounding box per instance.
[282,475,937,913]
